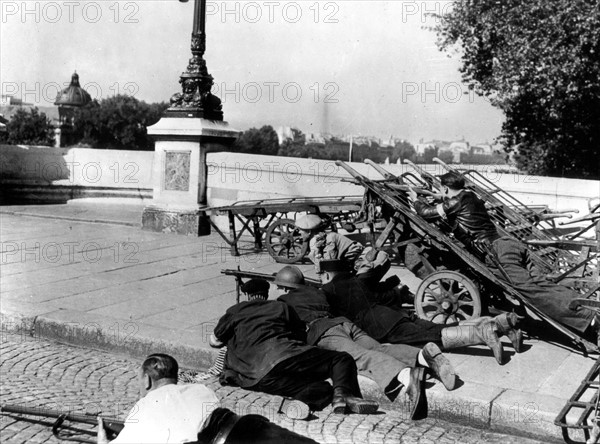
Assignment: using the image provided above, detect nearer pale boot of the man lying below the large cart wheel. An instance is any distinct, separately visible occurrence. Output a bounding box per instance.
[442,320,504,364]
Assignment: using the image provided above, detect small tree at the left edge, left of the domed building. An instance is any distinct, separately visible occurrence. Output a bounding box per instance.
[0,108,54,146]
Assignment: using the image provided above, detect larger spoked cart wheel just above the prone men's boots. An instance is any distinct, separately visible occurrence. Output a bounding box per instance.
[415,271,481,324]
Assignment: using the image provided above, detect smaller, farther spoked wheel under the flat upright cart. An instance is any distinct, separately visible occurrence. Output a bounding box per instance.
[265,219,308,264]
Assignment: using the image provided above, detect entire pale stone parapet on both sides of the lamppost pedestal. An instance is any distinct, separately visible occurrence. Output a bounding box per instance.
[0,145,600,219]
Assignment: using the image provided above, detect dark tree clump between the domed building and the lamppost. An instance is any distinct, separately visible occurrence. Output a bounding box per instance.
[73,95,168,150]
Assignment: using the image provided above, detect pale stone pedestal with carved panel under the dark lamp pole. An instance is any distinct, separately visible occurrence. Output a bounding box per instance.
[142,117,239,236]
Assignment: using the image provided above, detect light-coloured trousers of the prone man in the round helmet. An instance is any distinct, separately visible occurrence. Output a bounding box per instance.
[316,322,420,390]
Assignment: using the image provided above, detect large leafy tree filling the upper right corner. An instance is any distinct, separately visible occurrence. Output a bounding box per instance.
[435,0,600,179]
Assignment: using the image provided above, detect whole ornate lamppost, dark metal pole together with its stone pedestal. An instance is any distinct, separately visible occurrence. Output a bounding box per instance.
[142,0,239,236]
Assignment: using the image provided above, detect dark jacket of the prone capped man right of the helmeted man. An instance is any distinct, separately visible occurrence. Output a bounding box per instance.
[322,273,411,340]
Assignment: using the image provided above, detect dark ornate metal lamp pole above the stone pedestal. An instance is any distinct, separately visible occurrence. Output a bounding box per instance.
[165,0,223,121]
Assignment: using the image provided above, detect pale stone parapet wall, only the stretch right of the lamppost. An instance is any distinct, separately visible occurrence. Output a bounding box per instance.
[208,153,600,214]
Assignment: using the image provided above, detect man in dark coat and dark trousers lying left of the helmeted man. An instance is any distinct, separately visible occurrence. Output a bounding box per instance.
[211,280,378,418]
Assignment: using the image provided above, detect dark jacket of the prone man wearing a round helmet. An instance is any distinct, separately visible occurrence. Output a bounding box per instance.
[277,286,350,345]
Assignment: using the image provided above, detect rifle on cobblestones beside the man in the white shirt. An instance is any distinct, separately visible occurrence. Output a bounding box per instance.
[0,405,125,444]
